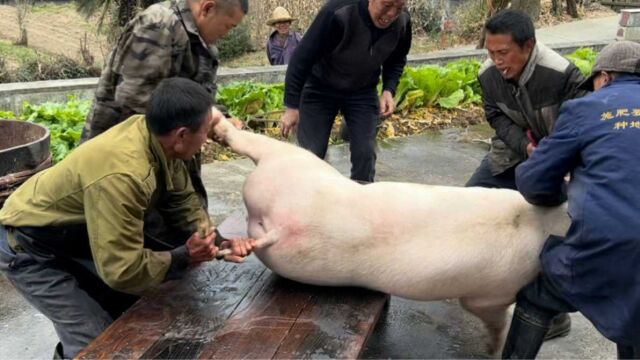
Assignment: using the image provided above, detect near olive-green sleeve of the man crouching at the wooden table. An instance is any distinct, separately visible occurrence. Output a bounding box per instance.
[84,174,171,294]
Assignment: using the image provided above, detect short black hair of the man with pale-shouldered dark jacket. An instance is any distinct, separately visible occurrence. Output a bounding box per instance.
[484,9,536,47]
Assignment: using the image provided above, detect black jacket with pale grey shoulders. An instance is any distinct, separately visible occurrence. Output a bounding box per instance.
[478,44,585,175]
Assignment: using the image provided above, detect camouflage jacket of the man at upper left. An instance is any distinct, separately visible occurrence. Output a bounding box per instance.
[82,0,218,140]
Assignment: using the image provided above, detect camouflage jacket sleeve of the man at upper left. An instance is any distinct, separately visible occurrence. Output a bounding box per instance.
[111,12,182,117]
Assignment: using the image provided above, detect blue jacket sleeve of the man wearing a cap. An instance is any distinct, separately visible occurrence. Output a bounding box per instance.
[516,102,581,206]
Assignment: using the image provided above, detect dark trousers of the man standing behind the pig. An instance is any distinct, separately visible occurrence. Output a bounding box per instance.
[298,84,380,182]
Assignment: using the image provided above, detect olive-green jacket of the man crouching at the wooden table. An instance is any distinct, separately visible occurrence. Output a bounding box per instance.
[0,115,209,294]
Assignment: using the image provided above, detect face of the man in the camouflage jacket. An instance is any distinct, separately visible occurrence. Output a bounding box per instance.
[191,0,244,44]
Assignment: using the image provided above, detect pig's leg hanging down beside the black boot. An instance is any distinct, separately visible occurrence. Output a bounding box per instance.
[460,298,513,355]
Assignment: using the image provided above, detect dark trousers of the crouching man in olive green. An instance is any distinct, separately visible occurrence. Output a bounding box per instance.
[0,225,172,358]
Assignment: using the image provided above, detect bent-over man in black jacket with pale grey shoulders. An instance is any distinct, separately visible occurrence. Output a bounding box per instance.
[466,10,585,339]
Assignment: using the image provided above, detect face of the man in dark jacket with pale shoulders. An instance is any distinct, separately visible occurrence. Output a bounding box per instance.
[485,33,535,81]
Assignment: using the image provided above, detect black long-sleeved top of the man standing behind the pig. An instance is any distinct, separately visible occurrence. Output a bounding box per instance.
[284,0,411,109]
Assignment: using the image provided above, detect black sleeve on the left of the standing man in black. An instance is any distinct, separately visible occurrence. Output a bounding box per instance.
[284,2,344,109]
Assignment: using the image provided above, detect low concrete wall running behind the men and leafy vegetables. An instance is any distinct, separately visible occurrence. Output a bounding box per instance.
[0,42,607,112]
